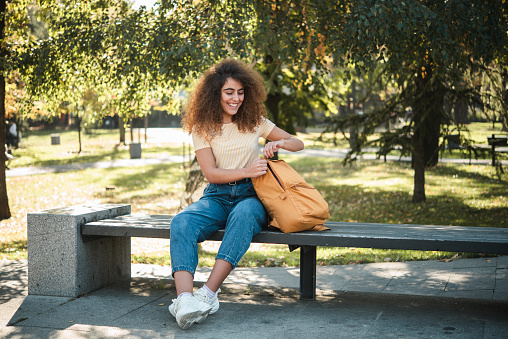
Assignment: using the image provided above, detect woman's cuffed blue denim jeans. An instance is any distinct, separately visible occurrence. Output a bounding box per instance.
[170,180,268,275]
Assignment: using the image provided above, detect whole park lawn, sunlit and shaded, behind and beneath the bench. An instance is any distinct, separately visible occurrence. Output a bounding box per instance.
[0,123,508,267]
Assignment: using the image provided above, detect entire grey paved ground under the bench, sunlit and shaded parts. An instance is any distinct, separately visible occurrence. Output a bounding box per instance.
[0,256,508,339]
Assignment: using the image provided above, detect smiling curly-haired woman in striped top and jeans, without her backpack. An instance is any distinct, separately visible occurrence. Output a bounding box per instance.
[169,59,304,329]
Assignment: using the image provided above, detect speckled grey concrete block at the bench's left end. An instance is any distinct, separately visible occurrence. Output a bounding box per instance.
[27,204,131,297]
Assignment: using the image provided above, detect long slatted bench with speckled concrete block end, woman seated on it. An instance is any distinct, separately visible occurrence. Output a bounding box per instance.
[28,205,508,300]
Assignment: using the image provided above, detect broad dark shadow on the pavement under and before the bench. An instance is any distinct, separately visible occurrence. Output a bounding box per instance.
[0,278,508,339]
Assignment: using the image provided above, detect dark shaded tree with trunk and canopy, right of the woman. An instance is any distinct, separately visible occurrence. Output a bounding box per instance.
[319,0,508,202]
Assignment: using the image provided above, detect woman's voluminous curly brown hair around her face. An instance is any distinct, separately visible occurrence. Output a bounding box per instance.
[182,59,267,137]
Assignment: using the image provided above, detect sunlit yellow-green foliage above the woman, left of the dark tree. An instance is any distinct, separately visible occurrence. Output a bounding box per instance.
[13,0,346,130]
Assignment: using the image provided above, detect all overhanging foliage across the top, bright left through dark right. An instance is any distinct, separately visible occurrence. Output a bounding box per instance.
[12,0,506,129]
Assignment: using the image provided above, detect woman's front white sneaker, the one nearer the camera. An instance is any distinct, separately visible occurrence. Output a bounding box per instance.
[169,295,212,330]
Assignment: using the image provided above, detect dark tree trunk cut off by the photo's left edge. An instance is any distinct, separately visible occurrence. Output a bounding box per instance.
[0,0,11,220]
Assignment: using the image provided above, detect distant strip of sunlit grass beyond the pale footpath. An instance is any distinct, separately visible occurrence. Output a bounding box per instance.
[11,123,507,167]
